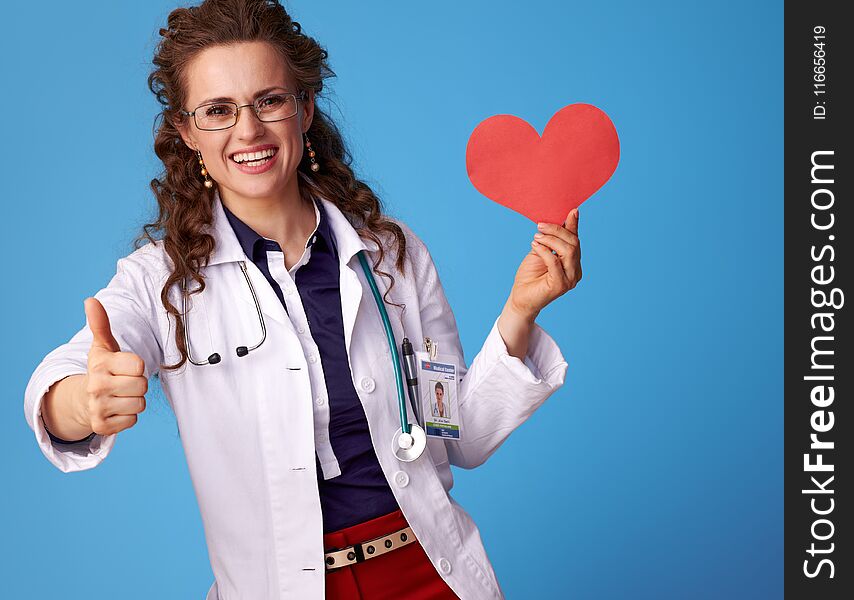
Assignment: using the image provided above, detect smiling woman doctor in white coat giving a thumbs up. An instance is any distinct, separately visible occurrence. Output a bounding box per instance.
[26,0,581,600]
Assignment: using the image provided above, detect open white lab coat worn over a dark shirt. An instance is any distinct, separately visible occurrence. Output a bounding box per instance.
[25,196,567,600]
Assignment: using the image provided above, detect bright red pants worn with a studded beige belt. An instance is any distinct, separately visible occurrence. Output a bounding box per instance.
[323,510,457,600]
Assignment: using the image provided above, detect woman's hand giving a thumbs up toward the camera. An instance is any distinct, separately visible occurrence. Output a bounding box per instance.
[80,298,148,435]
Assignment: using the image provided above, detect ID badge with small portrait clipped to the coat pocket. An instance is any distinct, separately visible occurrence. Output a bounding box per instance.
[415,351,461,440]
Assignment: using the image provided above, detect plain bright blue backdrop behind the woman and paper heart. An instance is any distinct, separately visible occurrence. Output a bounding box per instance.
[0,0,783,599]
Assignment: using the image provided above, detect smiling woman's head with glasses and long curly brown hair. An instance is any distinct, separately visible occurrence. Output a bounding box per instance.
[145,7,406,369]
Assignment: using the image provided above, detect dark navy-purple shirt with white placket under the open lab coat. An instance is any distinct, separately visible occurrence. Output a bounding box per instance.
[222,201,398,533]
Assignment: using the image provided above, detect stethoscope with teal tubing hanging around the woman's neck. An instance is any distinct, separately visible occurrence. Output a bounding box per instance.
[181,250,427,462]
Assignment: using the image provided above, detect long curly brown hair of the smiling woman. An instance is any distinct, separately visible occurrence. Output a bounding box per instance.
[134,0,406,369]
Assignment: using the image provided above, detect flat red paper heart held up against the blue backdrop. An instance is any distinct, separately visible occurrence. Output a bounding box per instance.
[466,104,620,224]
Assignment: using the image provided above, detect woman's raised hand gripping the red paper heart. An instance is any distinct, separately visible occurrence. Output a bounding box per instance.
[508,208,581,321]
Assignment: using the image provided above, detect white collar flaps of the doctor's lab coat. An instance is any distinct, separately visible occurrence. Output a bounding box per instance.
[208,185,379,265]
